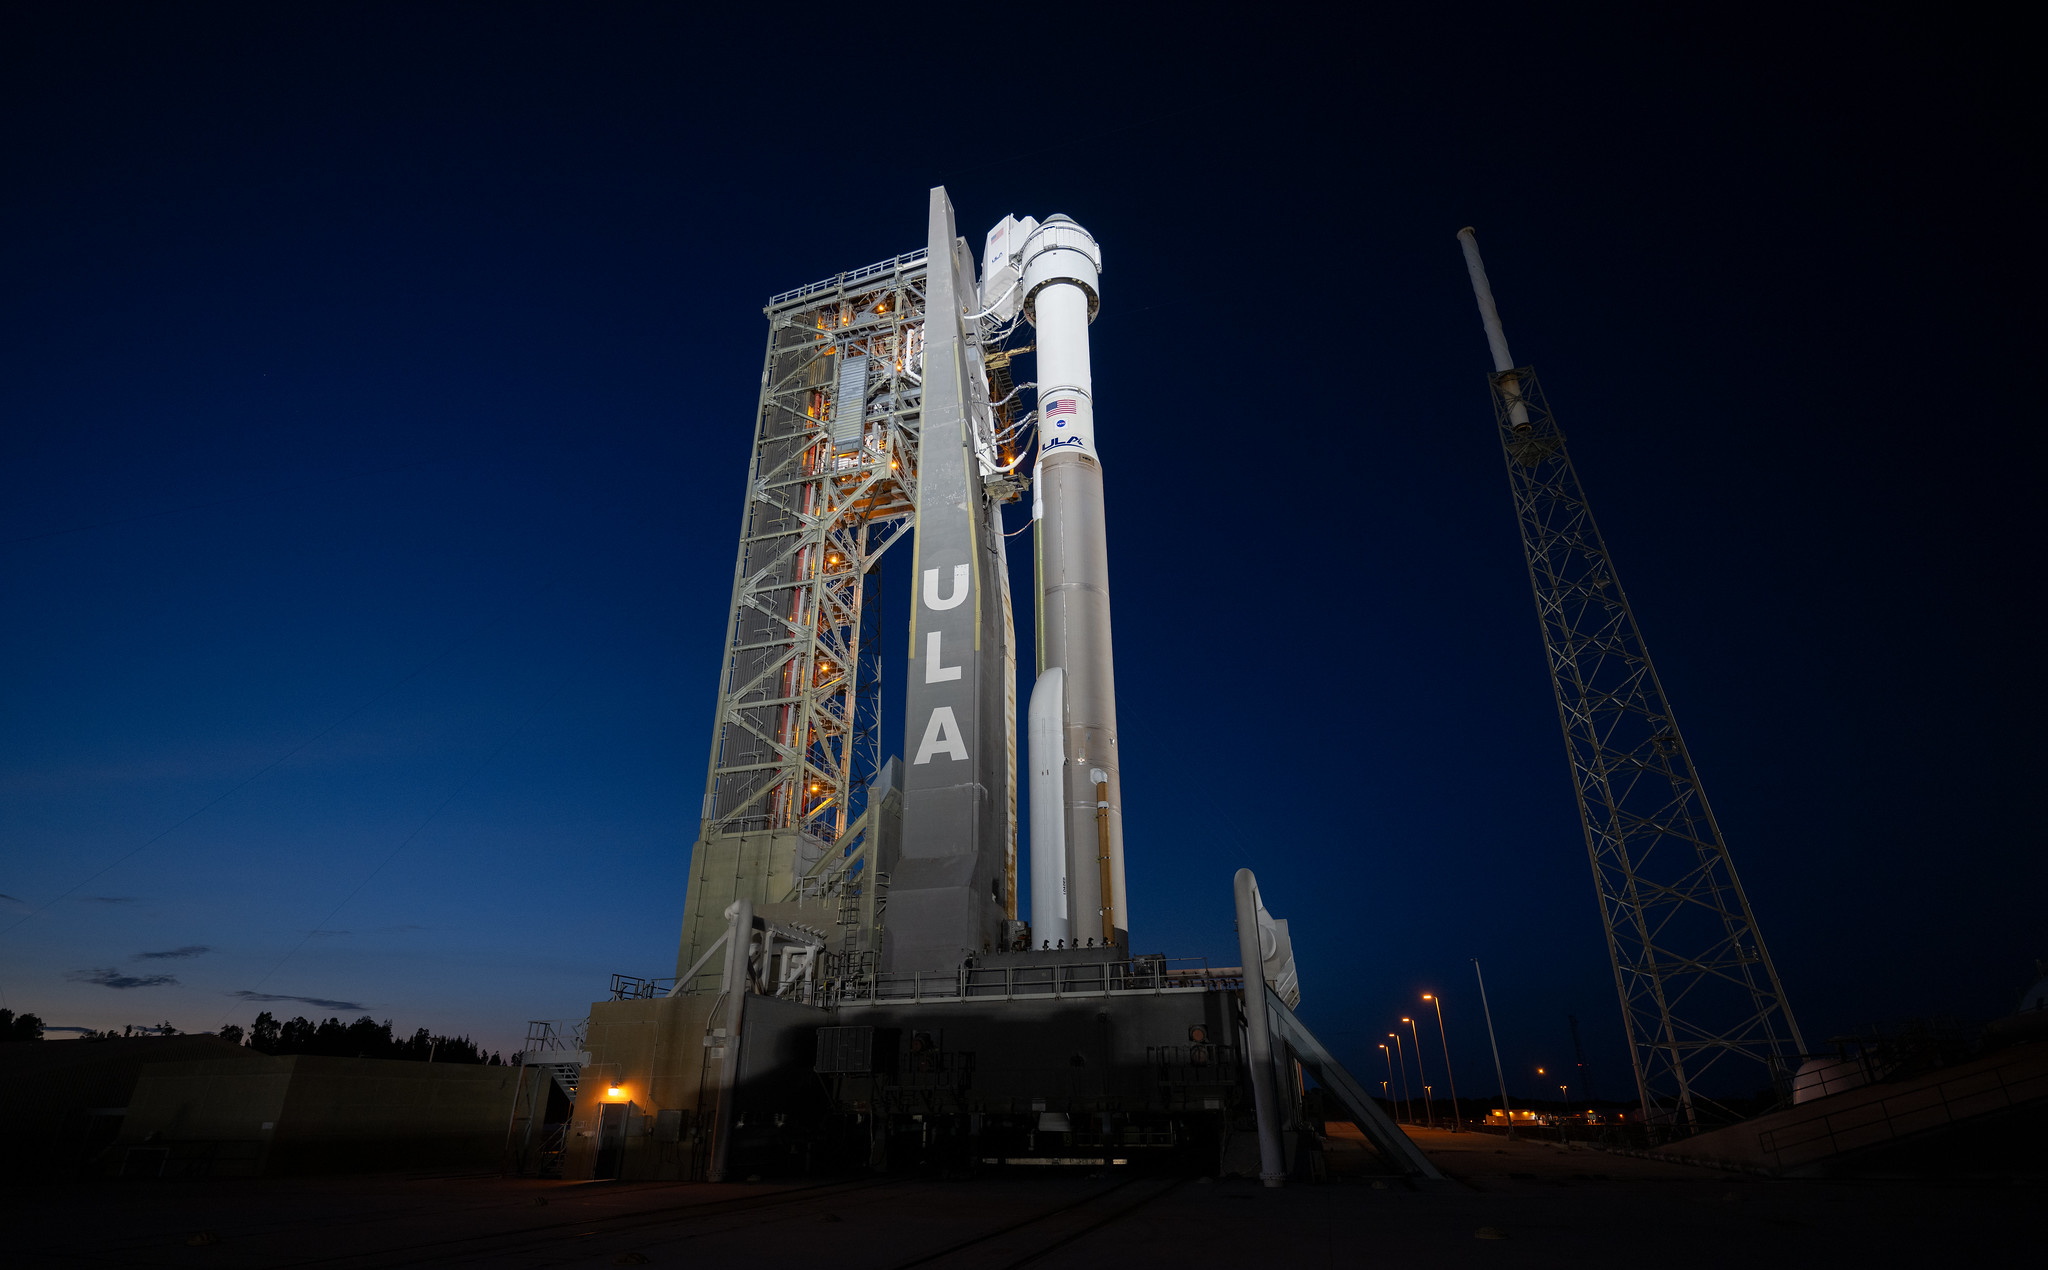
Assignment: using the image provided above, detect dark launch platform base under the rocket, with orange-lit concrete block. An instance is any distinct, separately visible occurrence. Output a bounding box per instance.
[561,950,1421,1182]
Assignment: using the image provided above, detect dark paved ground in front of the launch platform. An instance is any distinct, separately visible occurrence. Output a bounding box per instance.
[0,1129,2048,1270]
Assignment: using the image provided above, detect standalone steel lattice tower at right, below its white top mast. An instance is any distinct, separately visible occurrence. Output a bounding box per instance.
[1491,367,1804,1131]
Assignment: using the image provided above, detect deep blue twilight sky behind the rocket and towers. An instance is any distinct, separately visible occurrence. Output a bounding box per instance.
[0,4,2048,1096]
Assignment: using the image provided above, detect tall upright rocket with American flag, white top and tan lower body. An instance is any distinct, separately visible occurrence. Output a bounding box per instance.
[1020,215,1130,946]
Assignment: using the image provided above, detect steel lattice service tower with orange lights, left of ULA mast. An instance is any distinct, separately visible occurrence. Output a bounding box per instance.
[700,252,924,856]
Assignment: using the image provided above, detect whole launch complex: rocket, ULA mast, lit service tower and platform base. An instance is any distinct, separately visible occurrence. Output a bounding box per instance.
[512,188,1434,1184]
